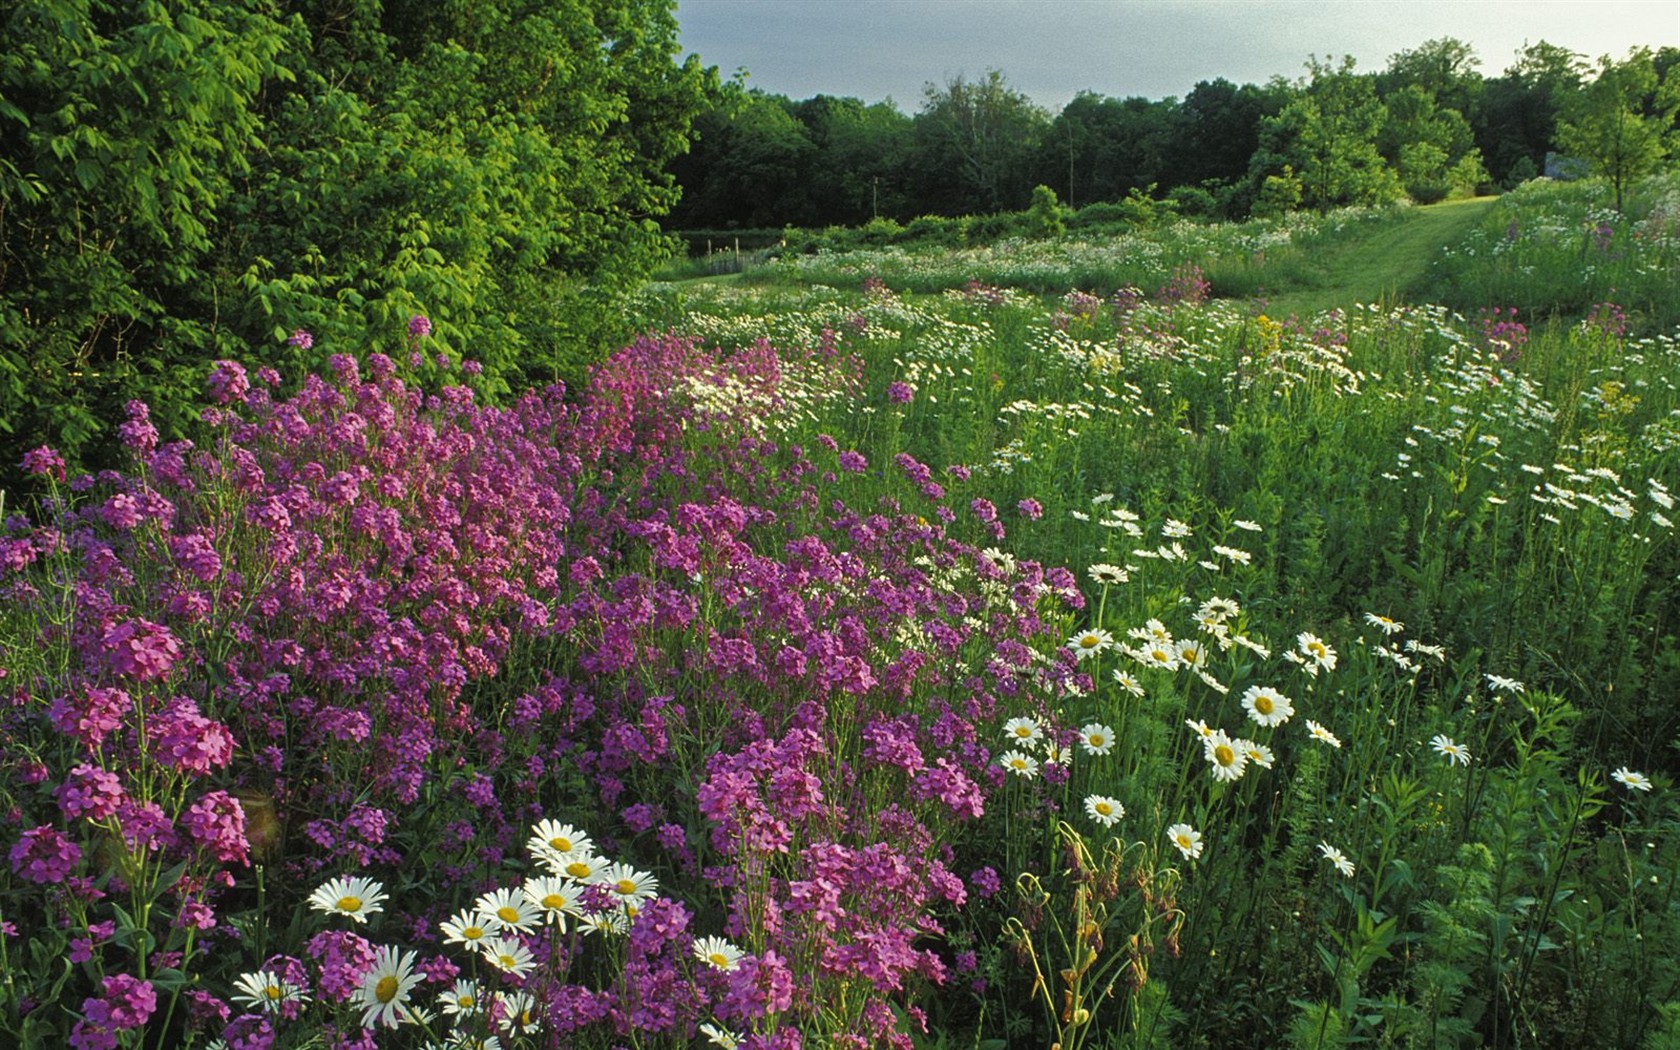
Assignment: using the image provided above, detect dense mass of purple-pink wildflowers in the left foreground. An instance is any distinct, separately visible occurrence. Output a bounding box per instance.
[0,328,1089,1047]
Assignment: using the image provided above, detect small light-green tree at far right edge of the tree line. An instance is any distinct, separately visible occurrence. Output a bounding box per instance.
[1557,47,1680,212]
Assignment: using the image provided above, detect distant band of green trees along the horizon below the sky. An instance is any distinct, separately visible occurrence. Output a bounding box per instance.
[667,37,1680,228]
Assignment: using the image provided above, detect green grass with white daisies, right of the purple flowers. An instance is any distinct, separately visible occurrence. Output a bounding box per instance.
[638,169,1680,1048]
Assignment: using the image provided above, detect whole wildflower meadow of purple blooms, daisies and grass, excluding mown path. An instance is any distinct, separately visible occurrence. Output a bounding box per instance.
[0,176,1680,1050]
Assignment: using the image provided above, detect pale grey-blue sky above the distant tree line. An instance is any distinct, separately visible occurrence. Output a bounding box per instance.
[677,0,1680,113]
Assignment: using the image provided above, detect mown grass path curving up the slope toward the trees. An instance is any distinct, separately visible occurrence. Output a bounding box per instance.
[1268,197,1495,316]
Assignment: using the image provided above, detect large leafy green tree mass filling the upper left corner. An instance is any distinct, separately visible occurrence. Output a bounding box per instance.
[0,0,706,483]
